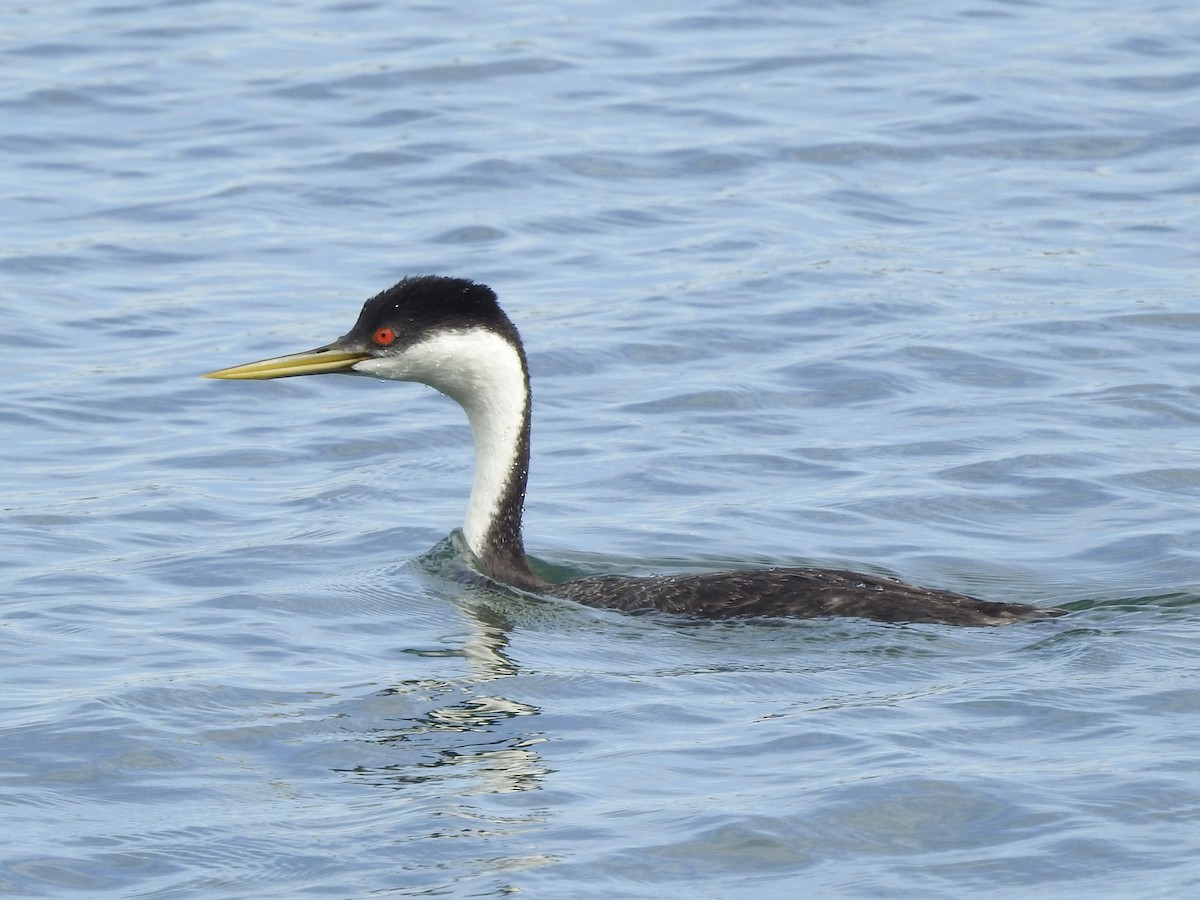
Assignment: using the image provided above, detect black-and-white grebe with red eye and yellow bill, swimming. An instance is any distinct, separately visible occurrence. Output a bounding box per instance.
[206,275,1064,625]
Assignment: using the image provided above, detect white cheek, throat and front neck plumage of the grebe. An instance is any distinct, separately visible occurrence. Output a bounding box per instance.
[354,328,528,557]
